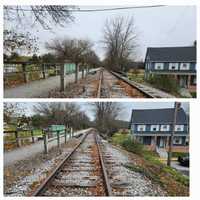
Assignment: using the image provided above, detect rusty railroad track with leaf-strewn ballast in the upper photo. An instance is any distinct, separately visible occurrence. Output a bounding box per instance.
[96,69,174,98]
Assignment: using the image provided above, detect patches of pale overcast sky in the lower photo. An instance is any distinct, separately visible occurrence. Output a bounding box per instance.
[15,102,189,121]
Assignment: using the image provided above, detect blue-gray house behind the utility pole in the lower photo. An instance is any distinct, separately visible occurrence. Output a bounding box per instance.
[130,108,189,152]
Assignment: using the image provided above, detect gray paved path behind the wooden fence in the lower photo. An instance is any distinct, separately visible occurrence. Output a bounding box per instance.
[4,129,89,167]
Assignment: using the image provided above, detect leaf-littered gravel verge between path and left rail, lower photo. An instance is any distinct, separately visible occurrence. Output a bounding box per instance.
[4,138,79,196]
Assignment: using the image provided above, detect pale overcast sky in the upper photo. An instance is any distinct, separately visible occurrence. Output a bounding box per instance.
[5,6,196,59]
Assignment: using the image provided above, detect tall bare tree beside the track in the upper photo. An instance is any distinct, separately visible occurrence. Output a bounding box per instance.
[103,17,137,70]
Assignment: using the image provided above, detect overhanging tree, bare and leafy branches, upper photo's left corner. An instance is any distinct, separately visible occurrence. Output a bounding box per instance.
[4,5,75,54]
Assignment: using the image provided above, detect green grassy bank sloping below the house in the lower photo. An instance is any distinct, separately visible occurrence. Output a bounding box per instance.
[111,133,189,191]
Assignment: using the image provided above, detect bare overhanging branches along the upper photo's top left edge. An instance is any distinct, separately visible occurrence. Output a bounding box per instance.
[4,5,75,30]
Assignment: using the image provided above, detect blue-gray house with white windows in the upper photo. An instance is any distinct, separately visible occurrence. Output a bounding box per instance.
[145,46,196,92]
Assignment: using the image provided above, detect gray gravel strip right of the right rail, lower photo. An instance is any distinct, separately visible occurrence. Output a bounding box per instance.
[101,138,166,196]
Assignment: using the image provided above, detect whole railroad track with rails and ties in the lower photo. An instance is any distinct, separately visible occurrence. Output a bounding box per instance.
[31,131,112,196]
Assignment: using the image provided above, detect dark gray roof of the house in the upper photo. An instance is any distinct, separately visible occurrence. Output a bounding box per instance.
[145,46,196,62]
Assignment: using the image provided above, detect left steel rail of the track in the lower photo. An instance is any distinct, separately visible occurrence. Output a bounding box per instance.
[31,132,89,196]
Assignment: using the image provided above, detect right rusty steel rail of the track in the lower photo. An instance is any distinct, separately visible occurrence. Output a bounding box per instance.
[95,134,113,196]
